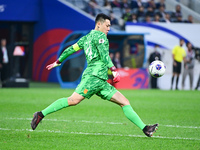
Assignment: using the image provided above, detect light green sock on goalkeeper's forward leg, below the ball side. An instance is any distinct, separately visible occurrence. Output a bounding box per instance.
[122,105,146,130]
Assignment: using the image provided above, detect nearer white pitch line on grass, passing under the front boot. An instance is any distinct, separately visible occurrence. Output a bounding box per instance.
[0,128,200,141]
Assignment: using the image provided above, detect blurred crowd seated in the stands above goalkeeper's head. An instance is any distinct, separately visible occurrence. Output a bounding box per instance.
[81,0,193,29]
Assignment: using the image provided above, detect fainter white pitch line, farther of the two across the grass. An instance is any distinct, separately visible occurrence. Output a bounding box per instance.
[4,118,200,129]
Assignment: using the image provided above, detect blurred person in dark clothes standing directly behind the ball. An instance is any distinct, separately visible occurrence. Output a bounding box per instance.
[149,45,161,89]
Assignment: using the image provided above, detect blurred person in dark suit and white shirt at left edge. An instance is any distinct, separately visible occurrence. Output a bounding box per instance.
[1,39,9,82]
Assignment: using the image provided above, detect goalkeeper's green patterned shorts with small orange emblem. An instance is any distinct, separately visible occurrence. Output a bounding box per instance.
[75,75,117,100]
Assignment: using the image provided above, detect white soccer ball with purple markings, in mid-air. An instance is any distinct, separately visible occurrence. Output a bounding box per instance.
[149,60,166,78]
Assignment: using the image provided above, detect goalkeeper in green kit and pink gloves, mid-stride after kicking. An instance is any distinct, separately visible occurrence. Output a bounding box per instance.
[31,13,158,137]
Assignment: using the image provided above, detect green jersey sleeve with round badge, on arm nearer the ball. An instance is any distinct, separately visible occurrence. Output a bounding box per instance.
[96,35,114,68]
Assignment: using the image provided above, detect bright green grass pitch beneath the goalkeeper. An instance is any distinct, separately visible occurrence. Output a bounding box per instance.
[0,83,200,150]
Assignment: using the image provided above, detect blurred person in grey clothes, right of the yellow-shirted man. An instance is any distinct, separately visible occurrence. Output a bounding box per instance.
[182,42,195,90]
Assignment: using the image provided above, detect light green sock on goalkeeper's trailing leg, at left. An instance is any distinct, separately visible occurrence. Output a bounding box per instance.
[42,98,69,116]
